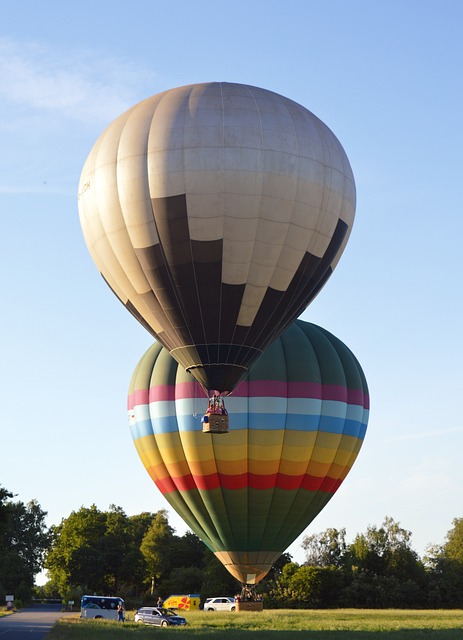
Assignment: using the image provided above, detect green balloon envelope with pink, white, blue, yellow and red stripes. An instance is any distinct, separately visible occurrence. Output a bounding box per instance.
[128,320,369,585]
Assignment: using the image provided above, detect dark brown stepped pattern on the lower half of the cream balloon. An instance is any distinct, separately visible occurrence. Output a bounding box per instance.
[119,195,347,391]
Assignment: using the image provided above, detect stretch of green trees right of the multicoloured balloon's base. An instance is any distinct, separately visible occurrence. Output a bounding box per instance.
[268,517,463,609]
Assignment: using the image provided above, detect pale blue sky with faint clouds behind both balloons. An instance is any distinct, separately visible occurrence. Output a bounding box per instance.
[0,0,463,580]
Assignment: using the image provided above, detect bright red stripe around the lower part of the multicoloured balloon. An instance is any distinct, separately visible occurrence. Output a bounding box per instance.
[156,473,342,494]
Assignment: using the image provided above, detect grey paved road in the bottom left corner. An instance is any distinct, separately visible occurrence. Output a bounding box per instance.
[0,604,72,640]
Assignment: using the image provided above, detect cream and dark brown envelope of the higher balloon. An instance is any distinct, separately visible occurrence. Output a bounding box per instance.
[79,82,355,395]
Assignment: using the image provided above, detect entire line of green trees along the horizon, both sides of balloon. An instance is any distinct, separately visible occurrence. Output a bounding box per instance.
[0,487,463,608]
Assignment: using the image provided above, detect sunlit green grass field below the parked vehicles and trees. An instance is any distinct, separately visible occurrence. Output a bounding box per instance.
[47,609,463,640]
